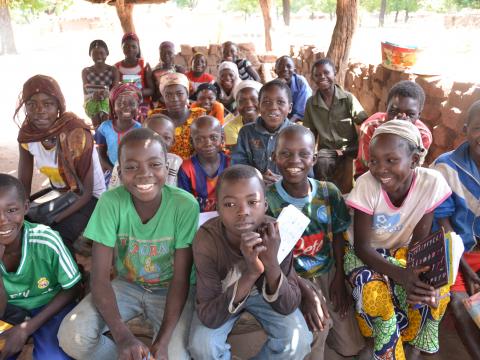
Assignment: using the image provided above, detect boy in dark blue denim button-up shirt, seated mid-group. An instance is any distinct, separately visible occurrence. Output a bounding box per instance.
[232,79,293,185]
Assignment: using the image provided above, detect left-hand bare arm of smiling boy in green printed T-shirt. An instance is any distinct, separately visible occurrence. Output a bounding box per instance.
[91,241,149,359]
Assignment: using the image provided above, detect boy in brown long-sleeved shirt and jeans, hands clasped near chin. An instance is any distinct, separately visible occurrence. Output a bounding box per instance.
[189,165,312,360]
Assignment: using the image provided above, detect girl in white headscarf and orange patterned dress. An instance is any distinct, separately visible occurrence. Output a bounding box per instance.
[154,73,205,159]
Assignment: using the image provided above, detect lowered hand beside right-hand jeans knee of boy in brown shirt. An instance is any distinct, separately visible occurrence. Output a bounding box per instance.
[300,286,330,332]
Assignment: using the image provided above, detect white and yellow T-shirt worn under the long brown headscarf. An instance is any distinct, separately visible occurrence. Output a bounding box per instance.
[22,141,106,199]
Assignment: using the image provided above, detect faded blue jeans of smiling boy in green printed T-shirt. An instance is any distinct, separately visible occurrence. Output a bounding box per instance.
[58,279,193,360]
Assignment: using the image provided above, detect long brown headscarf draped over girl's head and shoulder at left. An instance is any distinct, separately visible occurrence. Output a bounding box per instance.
[14,75,93,190]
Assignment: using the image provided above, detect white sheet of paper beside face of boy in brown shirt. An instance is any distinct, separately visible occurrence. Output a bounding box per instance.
[277,205,310,263]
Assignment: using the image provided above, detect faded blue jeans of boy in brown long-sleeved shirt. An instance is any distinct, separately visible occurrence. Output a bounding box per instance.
[188,294,312,360]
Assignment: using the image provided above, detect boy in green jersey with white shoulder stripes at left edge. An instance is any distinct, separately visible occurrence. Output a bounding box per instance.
[0,174,80,360]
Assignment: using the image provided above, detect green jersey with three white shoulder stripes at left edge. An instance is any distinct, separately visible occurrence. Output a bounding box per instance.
[0,221,81,310]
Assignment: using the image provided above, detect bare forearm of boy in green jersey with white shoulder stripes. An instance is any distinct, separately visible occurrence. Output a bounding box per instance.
[0,281,80,359]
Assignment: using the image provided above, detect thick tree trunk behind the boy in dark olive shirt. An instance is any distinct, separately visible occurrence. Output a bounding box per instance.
[327,0,358,86]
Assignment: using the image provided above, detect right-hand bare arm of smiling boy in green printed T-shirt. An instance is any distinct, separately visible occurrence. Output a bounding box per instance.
[151,247,193,360]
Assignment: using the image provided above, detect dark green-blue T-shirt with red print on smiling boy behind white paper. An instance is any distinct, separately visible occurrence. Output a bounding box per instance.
[267,178,350,277]
